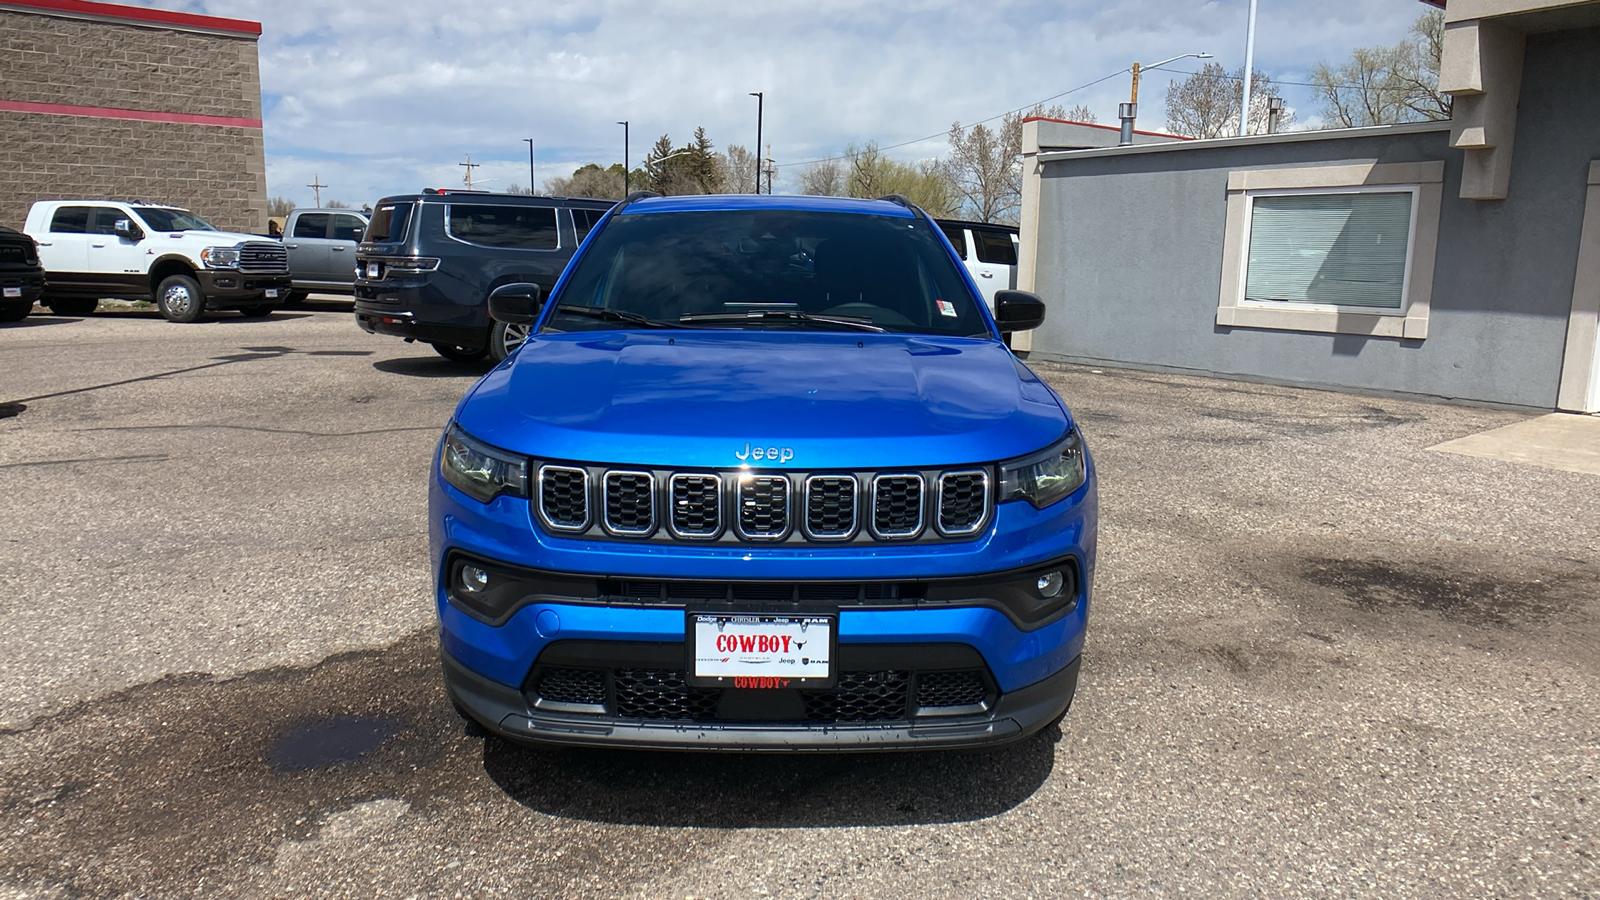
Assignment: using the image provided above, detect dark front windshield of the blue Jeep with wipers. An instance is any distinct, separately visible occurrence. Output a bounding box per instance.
[544,210,990,336]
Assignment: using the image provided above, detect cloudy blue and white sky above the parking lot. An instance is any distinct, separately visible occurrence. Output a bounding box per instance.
[123,0,1427,205]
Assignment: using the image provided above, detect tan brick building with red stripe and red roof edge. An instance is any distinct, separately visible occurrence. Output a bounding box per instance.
[0,0,267,232]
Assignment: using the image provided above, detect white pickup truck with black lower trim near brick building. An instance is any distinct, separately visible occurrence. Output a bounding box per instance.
[22,200,290,322]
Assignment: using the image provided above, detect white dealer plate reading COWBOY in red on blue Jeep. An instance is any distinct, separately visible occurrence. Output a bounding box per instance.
[688,613,835,690]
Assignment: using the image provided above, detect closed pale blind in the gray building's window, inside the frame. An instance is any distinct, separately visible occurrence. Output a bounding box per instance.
[1245,191,1411,309]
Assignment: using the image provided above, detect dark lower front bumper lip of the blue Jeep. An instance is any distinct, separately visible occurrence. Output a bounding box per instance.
[440,637,1080,753]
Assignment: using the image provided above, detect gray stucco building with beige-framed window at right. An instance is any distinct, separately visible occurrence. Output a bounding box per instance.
[1018,0,1600,412]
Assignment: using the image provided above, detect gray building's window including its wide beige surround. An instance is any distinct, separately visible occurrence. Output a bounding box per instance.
[1216,162,1443,340]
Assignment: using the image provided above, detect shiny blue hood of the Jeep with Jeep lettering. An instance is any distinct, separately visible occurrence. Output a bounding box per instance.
[456,330,1070,471]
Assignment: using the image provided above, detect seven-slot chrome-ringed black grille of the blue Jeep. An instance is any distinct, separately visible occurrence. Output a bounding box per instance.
[536,463,994,543]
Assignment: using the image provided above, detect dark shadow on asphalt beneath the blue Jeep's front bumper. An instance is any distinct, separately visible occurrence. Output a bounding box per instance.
[483,727,1061,828]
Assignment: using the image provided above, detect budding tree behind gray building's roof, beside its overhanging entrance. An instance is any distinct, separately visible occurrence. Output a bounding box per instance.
[1310,10,1450,128]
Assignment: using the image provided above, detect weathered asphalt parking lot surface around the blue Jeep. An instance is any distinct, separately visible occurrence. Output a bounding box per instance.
[0,303,1600,898]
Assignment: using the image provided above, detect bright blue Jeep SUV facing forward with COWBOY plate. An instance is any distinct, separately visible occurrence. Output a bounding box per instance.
[429,194,1096,751]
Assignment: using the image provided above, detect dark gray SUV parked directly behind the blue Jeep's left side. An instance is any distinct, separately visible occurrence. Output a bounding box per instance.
[355,189,614,360]
